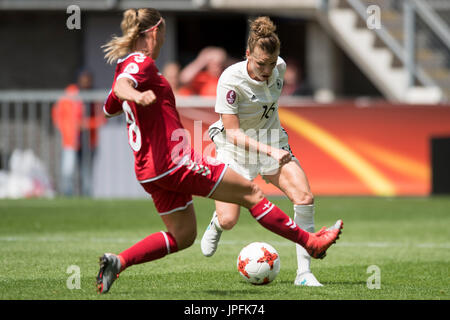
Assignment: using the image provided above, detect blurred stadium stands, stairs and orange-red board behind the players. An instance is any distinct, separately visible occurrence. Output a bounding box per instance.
[0,0,450,198]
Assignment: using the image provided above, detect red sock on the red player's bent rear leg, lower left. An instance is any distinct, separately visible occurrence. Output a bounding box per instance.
[119,231,178,271]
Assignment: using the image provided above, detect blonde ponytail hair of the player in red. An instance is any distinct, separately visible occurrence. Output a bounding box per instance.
[102,8,161,64]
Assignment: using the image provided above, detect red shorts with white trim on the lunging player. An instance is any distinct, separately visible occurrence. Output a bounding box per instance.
[141,152,227,215]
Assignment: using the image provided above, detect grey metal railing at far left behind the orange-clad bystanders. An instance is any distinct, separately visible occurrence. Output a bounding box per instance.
[0,90,107,196]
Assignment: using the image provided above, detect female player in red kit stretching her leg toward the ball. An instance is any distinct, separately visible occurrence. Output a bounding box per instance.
[97,8,342,293]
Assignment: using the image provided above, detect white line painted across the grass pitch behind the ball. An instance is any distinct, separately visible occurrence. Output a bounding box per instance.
[0,235,450,249]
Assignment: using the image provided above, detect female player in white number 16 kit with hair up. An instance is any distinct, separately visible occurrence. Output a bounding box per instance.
[201,17,322,286]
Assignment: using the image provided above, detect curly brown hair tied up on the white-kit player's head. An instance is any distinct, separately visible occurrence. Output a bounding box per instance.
[247,17,281,54]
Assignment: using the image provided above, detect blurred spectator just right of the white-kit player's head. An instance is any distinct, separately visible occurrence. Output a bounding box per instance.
[281,59,313,96]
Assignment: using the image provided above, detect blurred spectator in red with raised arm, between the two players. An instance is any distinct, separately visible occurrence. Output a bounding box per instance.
[179,47,227,96]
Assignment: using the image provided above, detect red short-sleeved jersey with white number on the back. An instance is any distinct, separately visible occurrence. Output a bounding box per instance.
[103,53,190,183]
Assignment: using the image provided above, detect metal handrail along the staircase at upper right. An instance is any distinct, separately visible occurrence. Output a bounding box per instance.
[319,0,450,101]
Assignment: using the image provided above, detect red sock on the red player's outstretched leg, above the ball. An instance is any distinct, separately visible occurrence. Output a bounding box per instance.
[250,198,309,247]
